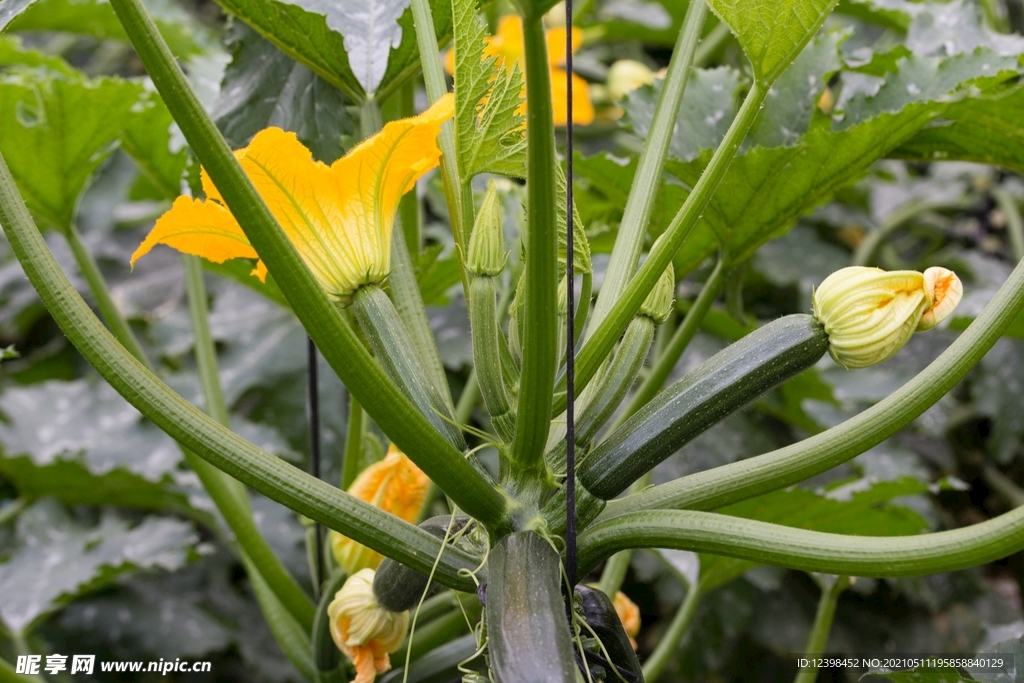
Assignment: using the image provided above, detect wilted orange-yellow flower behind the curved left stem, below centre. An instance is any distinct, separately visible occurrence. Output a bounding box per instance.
[331,444,430,575]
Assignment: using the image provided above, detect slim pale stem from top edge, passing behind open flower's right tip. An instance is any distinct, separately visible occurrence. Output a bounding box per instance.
[411,0,473,293]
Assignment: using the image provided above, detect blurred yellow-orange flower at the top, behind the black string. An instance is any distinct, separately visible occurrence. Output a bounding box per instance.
[444,14,594,126]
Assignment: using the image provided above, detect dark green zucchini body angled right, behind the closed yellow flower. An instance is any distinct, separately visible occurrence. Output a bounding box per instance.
[578,314,828,501]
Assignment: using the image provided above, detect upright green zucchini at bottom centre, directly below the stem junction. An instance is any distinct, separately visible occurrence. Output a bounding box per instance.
[484,531,577,683]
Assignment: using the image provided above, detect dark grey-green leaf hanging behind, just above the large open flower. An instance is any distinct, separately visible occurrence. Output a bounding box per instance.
[212,22,357,164]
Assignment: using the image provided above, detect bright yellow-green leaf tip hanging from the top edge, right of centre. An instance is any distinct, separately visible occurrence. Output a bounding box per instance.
[708,0,838,85]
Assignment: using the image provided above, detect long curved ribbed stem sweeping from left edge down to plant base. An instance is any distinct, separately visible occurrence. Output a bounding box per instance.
[0,152,481,590]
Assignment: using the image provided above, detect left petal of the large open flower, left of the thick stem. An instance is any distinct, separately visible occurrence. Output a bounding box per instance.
[131,197,256,274]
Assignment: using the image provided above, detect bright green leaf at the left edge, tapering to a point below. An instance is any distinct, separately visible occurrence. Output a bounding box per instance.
[0,70,142,230]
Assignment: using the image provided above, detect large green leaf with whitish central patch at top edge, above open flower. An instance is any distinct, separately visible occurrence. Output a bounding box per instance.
[218,0,452,101]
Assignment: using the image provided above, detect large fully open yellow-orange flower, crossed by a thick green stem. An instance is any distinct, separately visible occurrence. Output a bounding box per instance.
[131,95,455,303]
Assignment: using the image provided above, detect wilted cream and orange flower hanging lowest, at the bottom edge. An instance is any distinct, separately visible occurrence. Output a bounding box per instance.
[327,569,409,683]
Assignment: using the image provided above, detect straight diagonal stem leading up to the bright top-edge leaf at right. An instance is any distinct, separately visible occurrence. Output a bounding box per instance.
[561,82,768,401]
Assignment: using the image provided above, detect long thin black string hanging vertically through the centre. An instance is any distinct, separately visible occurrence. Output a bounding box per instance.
[565,0,577,586]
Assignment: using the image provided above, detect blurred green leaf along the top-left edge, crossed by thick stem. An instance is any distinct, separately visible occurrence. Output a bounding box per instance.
[0,0,216,57]
